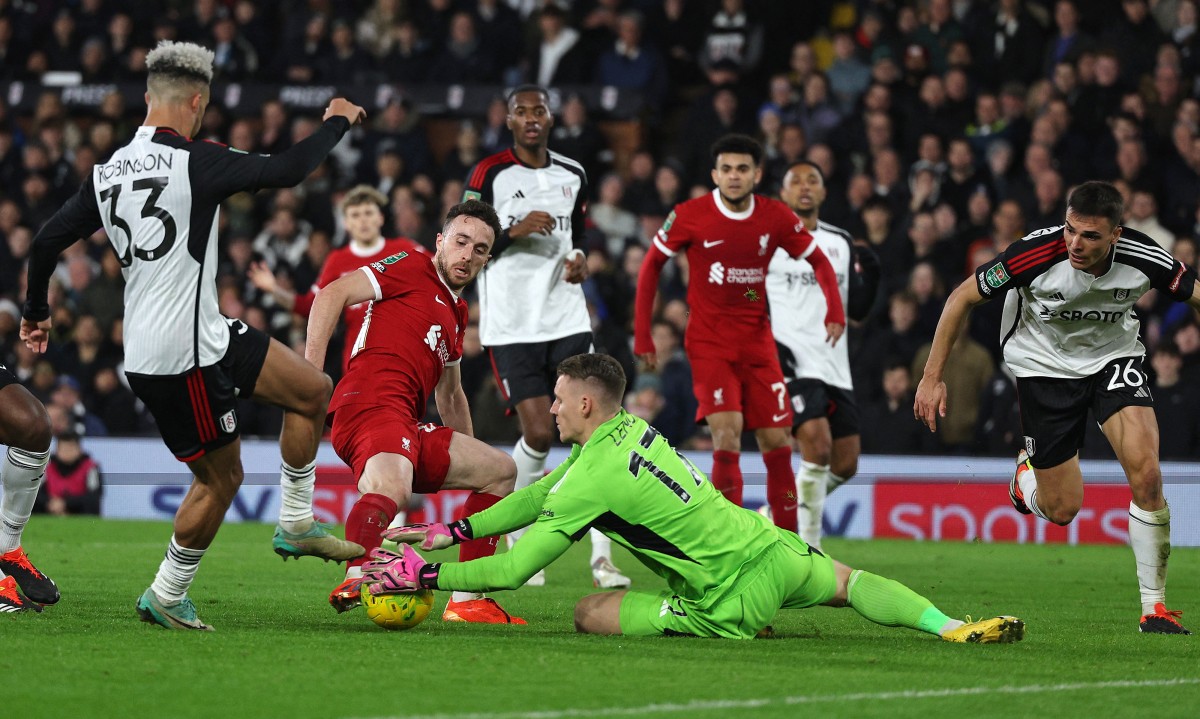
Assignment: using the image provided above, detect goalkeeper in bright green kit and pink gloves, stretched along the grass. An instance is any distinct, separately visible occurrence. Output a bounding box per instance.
[362,354,1025,643]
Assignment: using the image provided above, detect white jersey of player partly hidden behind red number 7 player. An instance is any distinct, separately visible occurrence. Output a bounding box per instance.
[767,221,853,390]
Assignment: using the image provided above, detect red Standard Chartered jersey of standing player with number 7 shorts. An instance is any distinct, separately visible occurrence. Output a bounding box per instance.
[634,190,816,359]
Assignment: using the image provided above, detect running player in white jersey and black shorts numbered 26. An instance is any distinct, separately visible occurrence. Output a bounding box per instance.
[913,182,1200,634]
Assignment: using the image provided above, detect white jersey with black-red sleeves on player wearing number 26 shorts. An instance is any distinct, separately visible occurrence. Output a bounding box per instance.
[976,226,1195,378]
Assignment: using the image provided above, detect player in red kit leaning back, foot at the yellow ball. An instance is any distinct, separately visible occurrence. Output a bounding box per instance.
[314,200,524,624]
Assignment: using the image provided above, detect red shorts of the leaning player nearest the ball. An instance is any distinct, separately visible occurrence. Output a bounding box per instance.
[332,405,454,495]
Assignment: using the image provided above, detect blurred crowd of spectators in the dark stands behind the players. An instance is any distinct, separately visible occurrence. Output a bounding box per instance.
[0,0,1200,459]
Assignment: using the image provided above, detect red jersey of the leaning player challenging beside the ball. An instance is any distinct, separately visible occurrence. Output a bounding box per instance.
[329,252,468,420]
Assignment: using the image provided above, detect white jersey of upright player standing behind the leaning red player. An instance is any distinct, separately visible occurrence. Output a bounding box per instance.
[464,150,592,347]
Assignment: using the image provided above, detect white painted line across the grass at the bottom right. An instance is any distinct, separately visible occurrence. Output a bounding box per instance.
[345,677,1200,719]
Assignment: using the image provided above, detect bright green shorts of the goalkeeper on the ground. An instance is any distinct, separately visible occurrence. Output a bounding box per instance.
[620,529,838,639]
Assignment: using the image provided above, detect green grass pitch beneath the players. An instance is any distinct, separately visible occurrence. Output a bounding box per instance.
[0,516,1200,719]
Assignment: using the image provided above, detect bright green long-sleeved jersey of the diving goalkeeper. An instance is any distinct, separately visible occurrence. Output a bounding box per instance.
[438,411,779,604]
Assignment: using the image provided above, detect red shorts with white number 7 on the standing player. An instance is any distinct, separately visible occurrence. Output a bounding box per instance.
[689,356,792,430]
